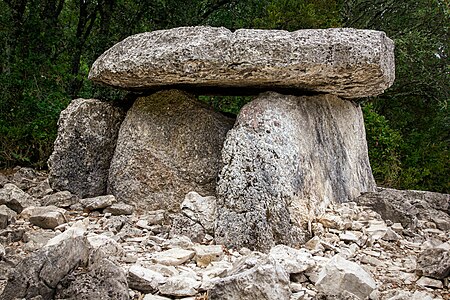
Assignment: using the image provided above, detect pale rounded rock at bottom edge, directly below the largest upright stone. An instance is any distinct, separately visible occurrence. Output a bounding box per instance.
[208,254,291,300]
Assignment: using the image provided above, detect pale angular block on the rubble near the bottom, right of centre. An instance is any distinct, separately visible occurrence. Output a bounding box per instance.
[316,254,376,299]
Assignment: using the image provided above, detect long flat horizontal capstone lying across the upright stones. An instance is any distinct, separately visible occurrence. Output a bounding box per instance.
[89,26,395,98]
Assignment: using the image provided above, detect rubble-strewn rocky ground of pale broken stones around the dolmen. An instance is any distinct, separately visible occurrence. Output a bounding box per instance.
[0,168,450,300]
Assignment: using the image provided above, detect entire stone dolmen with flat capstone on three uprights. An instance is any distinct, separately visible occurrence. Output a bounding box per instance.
[49,26,395,251]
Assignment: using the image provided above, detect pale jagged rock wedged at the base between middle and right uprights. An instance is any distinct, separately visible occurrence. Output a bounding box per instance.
[181,192,216,234]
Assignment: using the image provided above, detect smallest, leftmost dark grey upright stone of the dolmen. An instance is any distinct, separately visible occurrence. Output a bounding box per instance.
[48,99,125,198]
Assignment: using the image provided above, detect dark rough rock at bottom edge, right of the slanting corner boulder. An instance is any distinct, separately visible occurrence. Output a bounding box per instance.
[55,258,130,300]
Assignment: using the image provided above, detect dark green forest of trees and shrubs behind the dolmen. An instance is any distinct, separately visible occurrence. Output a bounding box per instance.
[0,0,450,193]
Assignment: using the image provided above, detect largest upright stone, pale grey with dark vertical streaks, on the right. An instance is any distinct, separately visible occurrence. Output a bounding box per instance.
[215,92,375,251]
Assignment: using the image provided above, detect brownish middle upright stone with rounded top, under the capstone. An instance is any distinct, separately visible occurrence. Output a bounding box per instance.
[108,90,233,211]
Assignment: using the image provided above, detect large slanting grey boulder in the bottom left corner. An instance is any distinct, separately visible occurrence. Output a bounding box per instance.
[0,237,89,300]
